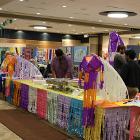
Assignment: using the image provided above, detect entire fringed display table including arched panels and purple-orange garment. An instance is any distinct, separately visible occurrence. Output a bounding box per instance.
[1,54,140,140]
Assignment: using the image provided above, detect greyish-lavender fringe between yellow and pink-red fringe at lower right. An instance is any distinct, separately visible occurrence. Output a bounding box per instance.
[103,107,130,140]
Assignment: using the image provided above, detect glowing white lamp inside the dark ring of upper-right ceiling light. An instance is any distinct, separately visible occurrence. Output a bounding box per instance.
[107,12,128,18]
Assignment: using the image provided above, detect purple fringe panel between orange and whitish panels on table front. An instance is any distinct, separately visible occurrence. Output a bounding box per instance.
[20,84,29,110]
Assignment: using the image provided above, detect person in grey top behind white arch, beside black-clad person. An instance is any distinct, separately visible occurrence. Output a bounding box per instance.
[114,46,126,74]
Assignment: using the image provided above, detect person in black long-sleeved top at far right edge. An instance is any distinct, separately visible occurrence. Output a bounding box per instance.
[120,50,140,98]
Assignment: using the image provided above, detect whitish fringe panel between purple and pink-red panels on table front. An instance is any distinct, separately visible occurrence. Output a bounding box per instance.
[28,87,37,113]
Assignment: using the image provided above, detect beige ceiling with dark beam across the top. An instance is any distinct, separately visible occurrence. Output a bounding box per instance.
[0,0,140,34]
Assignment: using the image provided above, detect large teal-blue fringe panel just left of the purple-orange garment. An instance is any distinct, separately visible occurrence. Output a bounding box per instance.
[68,99,83,138]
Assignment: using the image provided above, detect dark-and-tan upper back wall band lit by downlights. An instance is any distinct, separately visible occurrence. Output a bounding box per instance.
[0,29,88,48]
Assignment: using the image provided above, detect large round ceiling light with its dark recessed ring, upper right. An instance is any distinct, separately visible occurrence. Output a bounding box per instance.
[99,11,137,19]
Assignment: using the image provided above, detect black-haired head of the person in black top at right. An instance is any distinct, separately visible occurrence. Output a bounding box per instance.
[125,49,136,61]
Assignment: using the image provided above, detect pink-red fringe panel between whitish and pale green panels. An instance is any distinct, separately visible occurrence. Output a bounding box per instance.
[37,89,47,118]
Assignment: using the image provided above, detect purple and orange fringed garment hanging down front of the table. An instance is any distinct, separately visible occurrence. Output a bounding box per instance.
[79,54,104,126]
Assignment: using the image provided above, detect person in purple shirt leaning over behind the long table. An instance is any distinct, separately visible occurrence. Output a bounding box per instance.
[51,49,72,78]
